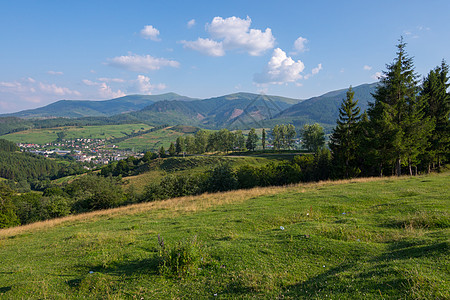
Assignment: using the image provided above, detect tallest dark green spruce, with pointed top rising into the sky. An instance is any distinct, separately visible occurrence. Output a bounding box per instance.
[368,38,422,176]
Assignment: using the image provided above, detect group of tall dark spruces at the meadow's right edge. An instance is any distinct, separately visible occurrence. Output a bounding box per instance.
[329,39,450,178]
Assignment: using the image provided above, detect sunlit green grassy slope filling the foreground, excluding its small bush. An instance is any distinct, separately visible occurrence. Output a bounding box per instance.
[0,173,450,299]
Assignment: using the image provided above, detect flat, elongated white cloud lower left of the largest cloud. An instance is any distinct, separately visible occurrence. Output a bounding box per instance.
[107,54,180,72]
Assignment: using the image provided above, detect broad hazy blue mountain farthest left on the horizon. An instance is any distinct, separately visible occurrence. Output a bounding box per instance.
[0,93,193,118]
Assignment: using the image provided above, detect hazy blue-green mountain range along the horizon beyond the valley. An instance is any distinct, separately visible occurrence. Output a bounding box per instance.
[0,83,377,131]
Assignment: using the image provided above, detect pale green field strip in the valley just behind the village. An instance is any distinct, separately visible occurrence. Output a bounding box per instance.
[1,124,152,144]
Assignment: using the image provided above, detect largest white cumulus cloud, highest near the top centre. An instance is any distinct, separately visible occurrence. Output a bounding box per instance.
[182,16,275,56]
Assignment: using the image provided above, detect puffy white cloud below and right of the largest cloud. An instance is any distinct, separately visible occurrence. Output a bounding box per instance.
[254,48,305,84]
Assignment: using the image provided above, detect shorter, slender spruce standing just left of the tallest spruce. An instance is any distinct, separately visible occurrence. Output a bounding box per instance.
[330,86,361,178]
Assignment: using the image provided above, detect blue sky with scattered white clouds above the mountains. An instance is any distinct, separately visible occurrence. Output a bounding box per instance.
[0,0,450,114]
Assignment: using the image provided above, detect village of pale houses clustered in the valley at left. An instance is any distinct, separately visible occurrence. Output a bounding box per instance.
[17,138,143,165]
